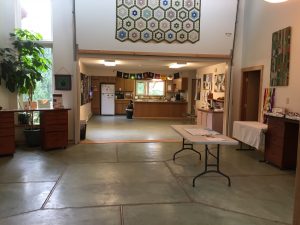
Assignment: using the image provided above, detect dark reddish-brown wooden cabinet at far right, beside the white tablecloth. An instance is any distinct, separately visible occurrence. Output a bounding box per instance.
[265,116,299,169]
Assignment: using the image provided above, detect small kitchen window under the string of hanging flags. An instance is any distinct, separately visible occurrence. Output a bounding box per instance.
[135,80,165,96]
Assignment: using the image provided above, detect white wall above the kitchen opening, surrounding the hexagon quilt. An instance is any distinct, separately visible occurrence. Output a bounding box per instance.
[76,0,237,55]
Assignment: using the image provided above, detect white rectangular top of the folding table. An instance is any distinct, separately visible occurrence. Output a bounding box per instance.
[171,125,238,145]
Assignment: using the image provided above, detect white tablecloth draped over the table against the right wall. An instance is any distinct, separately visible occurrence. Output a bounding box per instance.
[232,121,268,150]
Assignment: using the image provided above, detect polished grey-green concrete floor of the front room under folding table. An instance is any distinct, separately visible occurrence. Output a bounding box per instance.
[0,118,295,225]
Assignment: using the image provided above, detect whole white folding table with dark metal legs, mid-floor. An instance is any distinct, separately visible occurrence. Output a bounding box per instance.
[171,125,238,187]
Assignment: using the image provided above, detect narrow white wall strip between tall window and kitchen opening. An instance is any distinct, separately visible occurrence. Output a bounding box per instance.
[52,0,75,140]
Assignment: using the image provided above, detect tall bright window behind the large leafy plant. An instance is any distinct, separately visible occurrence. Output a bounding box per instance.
[19,0,53,104]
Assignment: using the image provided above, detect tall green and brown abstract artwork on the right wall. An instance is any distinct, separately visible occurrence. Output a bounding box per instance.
[270,27,291,86]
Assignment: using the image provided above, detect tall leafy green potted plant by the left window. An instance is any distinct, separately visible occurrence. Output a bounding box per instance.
[0,29,51,146]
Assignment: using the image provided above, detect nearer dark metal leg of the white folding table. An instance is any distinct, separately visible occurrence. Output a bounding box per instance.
[193,145,231,187]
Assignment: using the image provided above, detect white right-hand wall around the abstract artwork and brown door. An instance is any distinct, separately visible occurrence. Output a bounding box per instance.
[234,0,300,119]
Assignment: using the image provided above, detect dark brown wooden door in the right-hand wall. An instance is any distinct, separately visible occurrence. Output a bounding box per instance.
[240,66,263,121]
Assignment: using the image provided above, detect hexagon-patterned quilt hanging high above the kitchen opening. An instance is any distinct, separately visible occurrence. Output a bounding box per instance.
[116,0,201,43]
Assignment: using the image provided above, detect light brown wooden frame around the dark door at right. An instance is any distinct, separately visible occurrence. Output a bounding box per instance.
[239,65,264,122]
